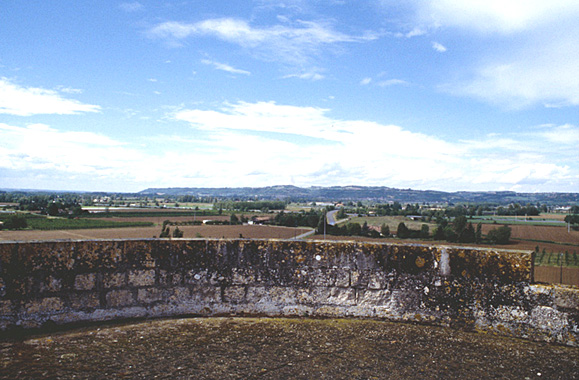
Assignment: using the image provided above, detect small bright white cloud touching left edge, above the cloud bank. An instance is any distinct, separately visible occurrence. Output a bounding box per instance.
[0,78,100,116]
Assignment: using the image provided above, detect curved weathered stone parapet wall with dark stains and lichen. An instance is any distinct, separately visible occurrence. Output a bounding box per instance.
[0,239,579,346]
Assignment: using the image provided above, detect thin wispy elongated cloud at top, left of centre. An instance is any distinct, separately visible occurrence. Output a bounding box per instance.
[149,18,377,64]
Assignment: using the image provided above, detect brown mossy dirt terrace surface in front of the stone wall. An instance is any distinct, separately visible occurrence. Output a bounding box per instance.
[0,318,579,380]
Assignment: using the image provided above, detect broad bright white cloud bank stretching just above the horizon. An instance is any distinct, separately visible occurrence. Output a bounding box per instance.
[0,102,579,191]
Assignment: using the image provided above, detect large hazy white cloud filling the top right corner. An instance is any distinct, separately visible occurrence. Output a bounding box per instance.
[402,0,579,108]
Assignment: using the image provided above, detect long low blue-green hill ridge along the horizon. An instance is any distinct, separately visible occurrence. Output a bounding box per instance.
[139,185,579,205]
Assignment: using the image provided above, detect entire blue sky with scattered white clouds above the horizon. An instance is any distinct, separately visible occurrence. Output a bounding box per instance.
[0,0,579,192]
